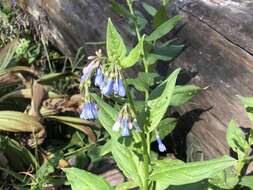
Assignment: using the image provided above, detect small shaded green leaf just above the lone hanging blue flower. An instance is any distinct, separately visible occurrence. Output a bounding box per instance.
[151,118,177,142]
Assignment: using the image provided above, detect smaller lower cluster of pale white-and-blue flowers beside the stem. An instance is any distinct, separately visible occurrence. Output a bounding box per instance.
[112,104,141,137]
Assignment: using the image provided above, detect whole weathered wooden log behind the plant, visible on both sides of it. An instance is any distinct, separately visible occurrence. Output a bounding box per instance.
[20,0,253,163]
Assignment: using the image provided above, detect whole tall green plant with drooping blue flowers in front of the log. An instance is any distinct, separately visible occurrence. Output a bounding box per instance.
[64,0,242,190]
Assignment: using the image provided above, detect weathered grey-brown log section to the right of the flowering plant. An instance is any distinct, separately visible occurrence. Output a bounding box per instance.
[169,0,253,159]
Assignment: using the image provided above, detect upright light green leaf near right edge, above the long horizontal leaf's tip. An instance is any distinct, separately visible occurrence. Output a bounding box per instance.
[227,120,249,160]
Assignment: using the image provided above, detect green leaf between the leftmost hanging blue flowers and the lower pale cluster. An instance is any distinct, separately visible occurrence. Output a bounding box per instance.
[91,93,120,138]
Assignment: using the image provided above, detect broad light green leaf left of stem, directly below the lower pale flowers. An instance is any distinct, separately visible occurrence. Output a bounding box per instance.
[112,140,145,187]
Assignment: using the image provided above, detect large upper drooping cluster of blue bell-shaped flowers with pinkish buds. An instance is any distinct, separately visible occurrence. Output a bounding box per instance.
[79,50,126,119]
